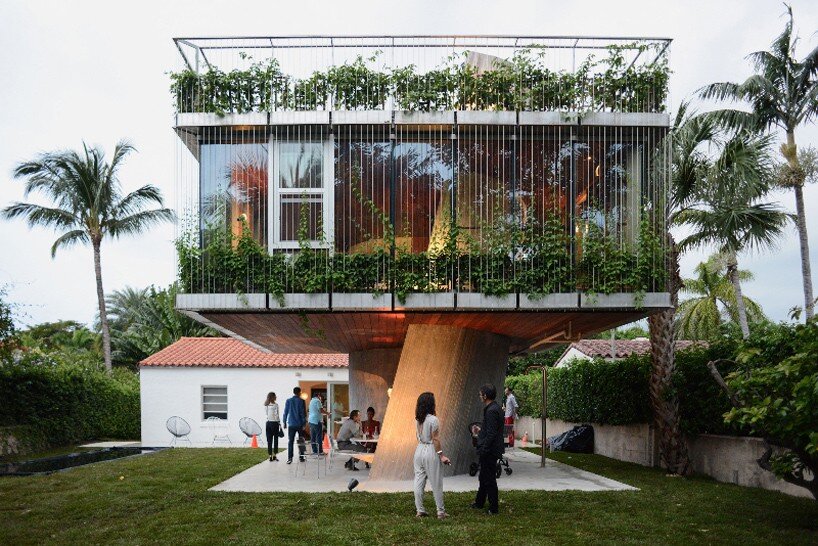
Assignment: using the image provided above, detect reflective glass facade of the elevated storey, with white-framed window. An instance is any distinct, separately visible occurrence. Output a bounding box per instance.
[186,124,666,295]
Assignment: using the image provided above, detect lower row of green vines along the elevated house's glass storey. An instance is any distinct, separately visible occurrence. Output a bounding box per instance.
[176,210,668,303]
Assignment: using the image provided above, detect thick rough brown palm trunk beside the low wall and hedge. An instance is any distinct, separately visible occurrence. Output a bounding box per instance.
[648,236,690,475]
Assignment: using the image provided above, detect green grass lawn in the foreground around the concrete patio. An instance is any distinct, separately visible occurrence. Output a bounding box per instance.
[0,449,818,546]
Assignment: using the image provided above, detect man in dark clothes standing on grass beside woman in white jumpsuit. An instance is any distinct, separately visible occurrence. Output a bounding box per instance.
[472,384,504,514]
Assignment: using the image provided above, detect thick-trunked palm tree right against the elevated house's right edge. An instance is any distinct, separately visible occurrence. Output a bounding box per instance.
[648,103,719,474]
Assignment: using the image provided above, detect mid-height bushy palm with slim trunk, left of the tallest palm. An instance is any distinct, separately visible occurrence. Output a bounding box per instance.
[678,131,790,339]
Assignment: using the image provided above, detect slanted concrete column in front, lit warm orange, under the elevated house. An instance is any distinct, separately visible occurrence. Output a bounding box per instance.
[370,324,510,480]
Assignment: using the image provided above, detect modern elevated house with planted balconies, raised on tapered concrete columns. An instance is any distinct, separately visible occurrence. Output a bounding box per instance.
[171,36,670,478]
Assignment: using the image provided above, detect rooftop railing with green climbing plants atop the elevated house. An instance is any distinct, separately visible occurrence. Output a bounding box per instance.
[171,35,670,115]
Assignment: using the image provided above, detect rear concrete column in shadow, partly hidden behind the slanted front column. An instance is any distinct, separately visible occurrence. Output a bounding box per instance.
[349,349,401,423]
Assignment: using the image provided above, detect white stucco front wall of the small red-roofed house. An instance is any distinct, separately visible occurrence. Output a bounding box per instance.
[139,366,349,447]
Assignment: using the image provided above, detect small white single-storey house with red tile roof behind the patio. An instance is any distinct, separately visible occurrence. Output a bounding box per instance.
[139,338,351,447]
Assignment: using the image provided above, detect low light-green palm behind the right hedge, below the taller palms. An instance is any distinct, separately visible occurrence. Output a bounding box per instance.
[676,254,766,340]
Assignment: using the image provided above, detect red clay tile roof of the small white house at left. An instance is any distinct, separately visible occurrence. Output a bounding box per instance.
[139,337,349,368]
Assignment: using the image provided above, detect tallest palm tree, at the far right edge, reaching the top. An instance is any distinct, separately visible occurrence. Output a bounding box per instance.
[700,6,818,320]
